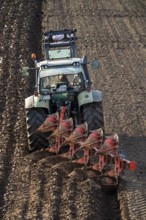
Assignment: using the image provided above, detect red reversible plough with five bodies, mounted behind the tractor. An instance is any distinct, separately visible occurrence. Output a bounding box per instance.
[37,108,136,190]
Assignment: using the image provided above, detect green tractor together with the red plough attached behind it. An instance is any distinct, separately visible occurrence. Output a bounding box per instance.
[23,29,136,189]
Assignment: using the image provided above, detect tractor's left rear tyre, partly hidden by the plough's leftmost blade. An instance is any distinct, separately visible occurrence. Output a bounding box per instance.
[26,108,49,151]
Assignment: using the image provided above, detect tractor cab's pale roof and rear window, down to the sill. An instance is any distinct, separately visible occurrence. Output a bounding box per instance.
[38,58,86,95]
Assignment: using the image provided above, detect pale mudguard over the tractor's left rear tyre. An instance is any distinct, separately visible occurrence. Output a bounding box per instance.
[25,95,49,110]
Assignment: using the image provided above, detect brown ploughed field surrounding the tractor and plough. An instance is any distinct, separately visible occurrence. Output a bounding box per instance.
[0,0,146,220]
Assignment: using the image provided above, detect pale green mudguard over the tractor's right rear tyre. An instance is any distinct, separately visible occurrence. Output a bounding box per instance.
[78,90,103,107]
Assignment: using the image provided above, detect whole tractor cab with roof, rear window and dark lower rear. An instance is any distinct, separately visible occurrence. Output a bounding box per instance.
[38,58,86,109]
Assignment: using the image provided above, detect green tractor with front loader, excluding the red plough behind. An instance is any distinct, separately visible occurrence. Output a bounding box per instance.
[23,29,104,151]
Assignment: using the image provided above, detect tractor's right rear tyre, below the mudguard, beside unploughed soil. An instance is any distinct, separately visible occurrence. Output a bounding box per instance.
[83,102,104,131]
